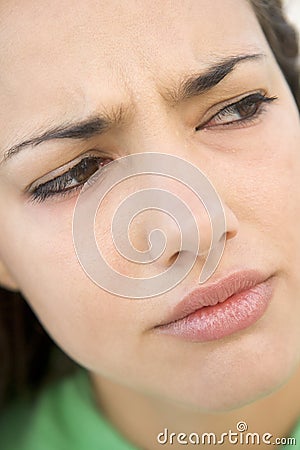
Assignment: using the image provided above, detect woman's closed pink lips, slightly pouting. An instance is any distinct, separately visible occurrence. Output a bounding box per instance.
[155,270,274,342]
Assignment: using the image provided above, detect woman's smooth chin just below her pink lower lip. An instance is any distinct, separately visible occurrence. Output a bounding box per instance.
[155,326,300,413]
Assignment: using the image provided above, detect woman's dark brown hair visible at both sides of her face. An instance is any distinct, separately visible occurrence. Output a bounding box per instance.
[0,0,300,404]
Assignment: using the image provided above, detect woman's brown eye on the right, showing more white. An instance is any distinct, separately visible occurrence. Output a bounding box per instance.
[196,92,277,131]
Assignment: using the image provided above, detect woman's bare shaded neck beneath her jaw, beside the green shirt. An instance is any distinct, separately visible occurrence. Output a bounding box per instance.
[91,368,300,450]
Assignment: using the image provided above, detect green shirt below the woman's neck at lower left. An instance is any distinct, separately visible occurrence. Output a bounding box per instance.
[0,370,300,450]
